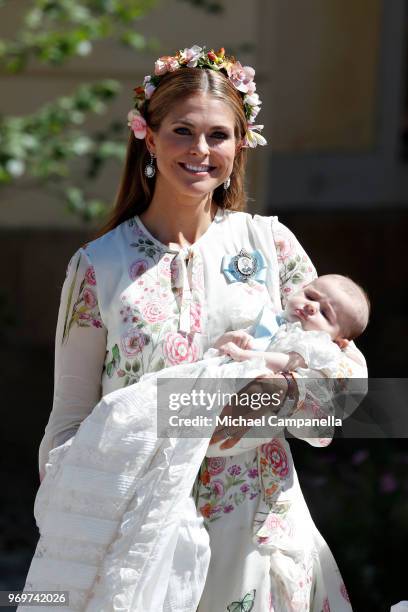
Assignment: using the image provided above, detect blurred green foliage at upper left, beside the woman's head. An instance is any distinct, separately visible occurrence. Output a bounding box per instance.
[0,0,156,221]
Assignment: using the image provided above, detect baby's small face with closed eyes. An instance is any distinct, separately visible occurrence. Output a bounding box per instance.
[285,277,353,340]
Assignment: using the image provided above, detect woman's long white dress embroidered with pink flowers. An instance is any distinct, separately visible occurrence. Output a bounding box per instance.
[31,210,366,612]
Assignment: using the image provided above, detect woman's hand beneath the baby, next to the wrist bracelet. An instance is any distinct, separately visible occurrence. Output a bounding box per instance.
[210,373,288,450]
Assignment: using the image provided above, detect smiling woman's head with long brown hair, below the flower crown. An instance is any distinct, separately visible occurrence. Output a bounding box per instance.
[97,66,249,236]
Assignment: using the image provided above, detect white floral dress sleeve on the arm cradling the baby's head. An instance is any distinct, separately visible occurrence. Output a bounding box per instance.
[272,219,367,446]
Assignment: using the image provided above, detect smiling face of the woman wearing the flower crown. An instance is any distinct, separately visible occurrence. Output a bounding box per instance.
[146,93,237,199]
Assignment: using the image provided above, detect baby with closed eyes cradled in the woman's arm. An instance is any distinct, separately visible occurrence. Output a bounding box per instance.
[214,274,370,373]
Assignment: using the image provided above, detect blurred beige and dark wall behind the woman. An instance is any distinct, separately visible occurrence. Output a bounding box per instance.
[0,0,408,612]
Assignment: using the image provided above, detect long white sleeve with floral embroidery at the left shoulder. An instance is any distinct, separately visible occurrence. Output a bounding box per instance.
[39,248,107,480]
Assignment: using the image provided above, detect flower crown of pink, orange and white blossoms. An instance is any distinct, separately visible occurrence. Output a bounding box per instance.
[128,45,266,148]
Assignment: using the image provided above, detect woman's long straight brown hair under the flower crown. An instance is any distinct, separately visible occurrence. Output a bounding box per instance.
[95,68,247,238]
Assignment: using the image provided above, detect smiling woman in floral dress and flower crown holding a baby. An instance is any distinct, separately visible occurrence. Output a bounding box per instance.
[26,46,366,612]
